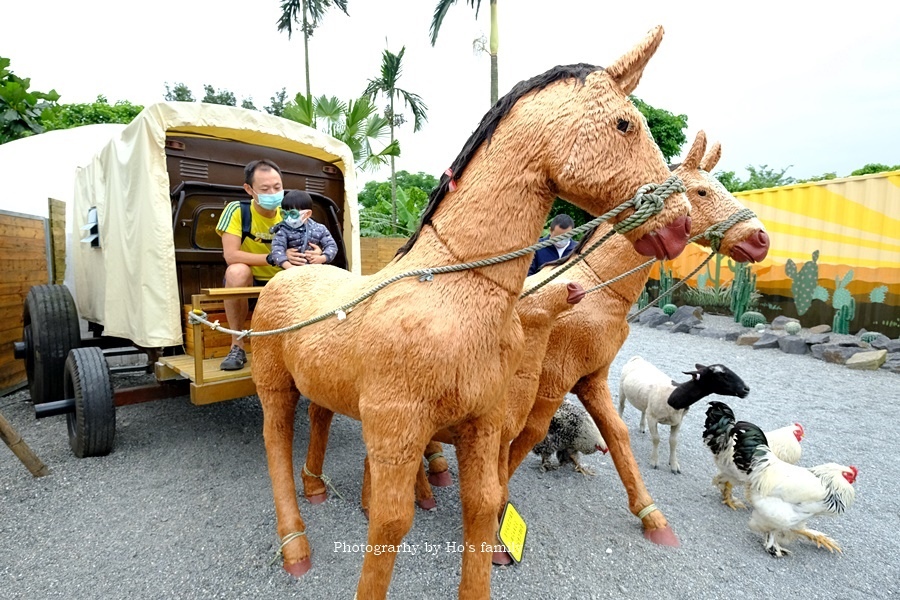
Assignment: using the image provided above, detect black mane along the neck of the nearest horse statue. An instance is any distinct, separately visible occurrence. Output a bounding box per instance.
[397,63,603,256]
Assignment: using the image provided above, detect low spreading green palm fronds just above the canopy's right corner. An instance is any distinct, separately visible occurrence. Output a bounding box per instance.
[281,94,400,171]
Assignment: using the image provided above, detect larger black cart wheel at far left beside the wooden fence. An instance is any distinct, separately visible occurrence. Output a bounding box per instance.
[22,285,81,404]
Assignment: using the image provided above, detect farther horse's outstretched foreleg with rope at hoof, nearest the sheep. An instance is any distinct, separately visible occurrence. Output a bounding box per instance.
[574,369,680,547]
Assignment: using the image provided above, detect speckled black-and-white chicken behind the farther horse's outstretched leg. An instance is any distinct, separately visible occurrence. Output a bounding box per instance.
[532,400,609,476]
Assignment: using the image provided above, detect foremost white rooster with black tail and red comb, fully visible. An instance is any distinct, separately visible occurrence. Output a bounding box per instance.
[734,421,859,557]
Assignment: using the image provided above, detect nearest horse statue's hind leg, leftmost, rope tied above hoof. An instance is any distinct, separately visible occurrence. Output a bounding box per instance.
[256,385,312,577]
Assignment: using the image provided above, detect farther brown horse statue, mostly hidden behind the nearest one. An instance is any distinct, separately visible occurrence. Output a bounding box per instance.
[303,131,769,562]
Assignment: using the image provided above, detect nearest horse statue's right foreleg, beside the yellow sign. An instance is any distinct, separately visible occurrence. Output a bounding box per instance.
[454,411,502,600]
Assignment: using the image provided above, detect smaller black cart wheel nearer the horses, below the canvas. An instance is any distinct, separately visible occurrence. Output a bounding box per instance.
[64,348,116,458]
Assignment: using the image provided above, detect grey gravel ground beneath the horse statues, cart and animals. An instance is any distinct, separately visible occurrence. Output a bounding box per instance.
[0,316,900,600]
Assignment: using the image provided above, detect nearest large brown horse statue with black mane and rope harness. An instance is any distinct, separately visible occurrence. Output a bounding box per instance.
[252,27,690,600]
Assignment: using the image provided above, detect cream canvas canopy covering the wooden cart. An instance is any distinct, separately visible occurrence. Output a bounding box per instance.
[69,102,360,348]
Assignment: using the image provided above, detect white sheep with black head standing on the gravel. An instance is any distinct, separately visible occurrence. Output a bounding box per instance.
[619,356,750,473]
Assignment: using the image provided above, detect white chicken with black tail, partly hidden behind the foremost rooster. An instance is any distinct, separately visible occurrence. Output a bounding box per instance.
[703,401,804,510]
